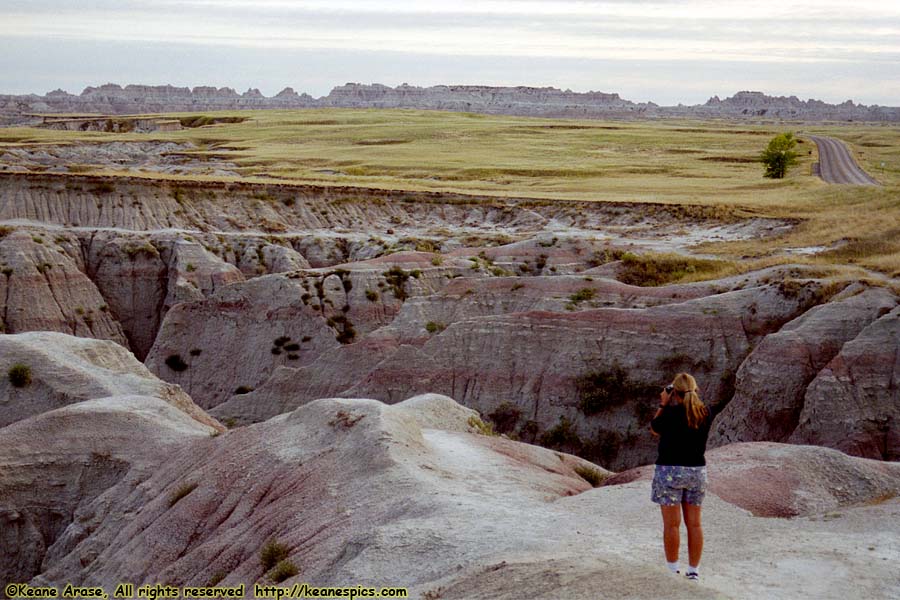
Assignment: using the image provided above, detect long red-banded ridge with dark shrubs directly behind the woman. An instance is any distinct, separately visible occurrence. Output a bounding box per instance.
[207,282,827,468]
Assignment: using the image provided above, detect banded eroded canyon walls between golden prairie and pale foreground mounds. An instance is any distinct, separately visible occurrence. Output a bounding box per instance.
[0,174,897,468]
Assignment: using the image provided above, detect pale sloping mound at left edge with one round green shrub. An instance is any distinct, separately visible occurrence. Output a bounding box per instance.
[0,332,223,430]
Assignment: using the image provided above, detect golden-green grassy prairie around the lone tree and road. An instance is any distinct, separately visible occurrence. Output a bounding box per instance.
[0,109,900,276]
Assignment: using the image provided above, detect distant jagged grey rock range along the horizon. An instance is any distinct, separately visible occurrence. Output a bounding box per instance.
[0,83,900,123]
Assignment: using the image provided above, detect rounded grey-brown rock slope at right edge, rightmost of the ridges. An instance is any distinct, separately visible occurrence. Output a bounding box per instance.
[789,307,900,461]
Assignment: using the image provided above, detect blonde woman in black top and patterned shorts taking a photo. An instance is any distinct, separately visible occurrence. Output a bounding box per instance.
[650,373,711,580]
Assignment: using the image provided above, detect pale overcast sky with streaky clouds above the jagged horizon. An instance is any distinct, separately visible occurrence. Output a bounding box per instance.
[0,0,900,106]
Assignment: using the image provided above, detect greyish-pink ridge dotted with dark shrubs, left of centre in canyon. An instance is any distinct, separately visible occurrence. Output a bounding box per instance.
[147,253,482,407]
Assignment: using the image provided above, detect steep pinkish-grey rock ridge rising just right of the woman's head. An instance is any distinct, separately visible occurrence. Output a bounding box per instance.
[710,285,898,446]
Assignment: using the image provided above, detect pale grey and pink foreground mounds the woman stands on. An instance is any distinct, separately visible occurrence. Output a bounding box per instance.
[0,354,900,599]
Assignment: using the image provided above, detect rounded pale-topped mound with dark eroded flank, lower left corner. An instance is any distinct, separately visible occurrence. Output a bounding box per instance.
[0,392,216,582]
